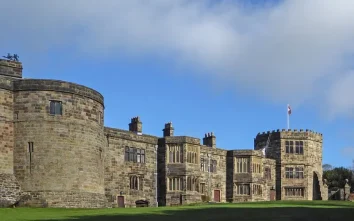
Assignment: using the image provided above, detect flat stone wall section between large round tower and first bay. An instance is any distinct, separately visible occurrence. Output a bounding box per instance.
[105,128,158,207]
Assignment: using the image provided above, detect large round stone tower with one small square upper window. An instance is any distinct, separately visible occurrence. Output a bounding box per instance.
[13,79,106,208]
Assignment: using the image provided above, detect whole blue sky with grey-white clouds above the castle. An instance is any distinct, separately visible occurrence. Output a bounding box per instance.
[0,0,354,167]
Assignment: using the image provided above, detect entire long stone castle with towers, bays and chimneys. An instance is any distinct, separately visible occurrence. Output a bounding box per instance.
[0,59,328,208]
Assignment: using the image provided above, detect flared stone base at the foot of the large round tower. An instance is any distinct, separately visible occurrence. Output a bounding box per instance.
[19,192,107,208]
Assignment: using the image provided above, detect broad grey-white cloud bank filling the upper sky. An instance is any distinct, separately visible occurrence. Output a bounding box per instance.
[0,0,354,117]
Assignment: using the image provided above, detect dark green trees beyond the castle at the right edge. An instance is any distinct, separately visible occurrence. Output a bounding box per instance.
[323,167,354,189]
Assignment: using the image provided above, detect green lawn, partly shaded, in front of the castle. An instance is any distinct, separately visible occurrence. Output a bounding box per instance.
[0,201,354,221]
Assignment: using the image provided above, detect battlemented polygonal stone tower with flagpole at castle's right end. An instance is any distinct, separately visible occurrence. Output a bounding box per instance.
[254,129,327,200]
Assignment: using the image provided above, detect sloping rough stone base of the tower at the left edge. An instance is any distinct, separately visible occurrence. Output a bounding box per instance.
[0,174,21,207]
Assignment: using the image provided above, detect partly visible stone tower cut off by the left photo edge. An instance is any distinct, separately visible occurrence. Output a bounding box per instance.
[0,59,22,207]
